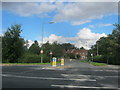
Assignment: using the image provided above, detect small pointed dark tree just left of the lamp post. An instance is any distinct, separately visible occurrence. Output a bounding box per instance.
[29,40,40,55]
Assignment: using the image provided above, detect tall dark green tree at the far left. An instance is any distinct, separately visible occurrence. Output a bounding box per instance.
[2,24,24,63]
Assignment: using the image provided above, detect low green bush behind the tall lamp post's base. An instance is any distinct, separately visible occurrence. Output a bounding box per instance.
[18,53,50,63]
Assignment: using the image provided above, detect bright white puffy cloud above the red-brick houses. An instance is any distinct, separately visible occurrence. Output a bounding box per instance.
[75,28,107,49]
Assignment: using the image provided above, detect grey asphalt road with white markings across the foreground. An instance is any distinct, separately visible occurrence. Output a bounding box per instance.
[1,60,118,90]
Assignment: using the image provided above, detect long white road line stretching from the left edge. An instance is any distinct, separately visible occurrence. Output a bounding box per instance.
[2,74,96,81]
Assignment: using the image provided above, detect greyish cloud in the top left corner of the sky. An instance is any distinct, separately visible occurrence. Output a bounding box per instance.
[3,2,55,16]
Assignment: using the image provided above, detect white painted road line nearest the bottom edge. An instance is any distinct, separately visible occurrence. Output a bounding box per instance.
[51,85,120,90]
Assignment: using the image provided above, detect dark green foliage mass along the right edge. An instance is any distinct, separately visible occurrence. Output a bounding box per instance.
[90,24,120,64]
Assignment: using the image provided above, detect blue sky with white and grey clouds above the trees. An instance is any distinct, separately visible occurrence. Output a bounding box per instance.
[2,2,118,49]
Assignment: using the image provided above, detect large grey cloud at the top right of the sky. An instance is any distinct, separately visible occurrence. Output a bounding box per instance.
[54,2,117,22]
